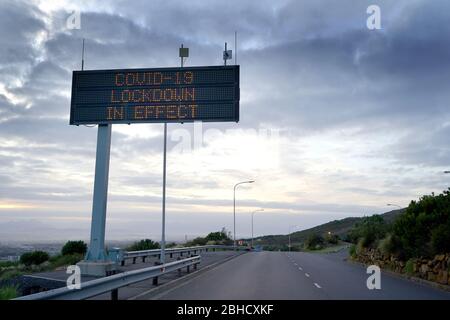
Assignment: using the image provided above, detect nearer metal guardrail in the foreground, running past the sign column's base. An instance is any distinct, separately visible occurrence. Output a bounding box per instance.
[14,256,201,300]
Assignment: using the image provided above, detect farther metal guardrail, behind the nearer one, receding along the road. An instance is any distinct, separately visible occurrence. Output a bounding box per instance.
[117,245,248,266]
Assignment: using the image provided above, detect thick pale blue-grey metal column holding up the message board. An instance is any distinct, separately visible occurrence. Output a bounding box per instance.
[85,124,112,261]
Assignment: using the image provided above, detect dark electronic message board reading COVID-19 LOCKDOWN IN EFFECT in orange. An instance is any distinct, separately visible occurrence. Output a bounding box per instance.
[70,66,239,125]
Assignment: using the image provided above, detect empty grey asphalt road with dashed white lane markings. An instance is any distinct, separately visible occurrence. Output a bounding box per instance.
[151,252,450,300]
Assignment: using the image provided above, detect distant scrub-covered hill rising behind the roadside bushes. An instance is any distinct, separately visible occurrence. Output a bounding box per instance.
[248,209,404,248]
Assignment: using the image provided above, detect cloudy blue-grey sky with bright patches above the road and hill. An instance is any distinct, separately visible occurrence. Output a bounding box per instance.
[0,0,450,241]
